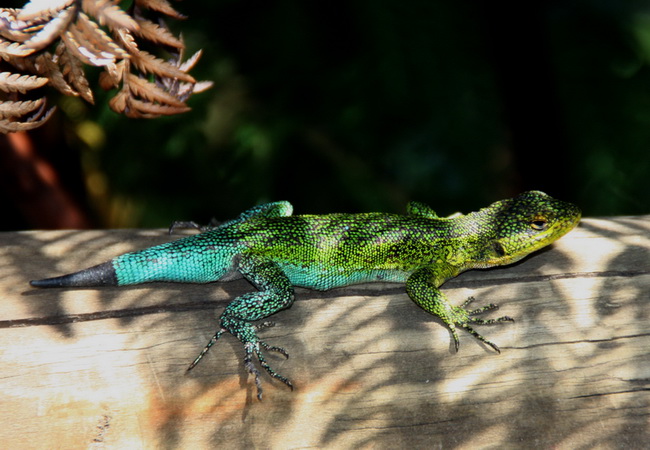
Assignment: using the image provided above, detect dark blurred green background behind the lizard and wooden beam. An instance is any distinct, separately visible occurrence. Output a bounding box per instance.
[0,0,650,229]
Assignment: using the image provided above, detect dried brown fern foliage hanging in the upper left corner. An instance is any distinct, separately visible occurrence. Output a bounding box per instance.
[0,0,211,132]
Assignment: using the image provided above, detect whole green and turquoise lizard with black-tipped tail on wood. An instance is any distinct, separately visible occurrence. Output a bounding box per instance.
[31,191,580,399]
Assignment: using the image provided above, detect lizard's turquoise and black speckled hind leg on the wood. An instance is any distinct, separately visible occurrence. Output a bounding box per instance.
[187,255,294,400]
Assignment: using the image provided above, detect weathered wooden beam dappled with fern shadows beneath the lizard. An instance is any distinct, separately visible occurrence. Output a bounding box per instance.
[0,216,650,449]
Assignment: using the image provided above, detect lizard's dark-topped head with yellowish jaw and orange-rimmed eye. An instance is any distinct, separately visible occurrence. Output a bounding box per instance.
[475,191,581,267]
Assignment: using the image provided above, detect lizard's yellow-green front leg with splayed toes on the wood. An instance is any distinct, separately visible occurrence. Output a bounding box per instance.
[406,269,514,353]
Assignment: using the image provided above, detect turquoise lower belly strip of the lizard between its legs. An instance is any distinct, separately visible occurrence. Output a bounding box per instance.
[280,263,410,291]
